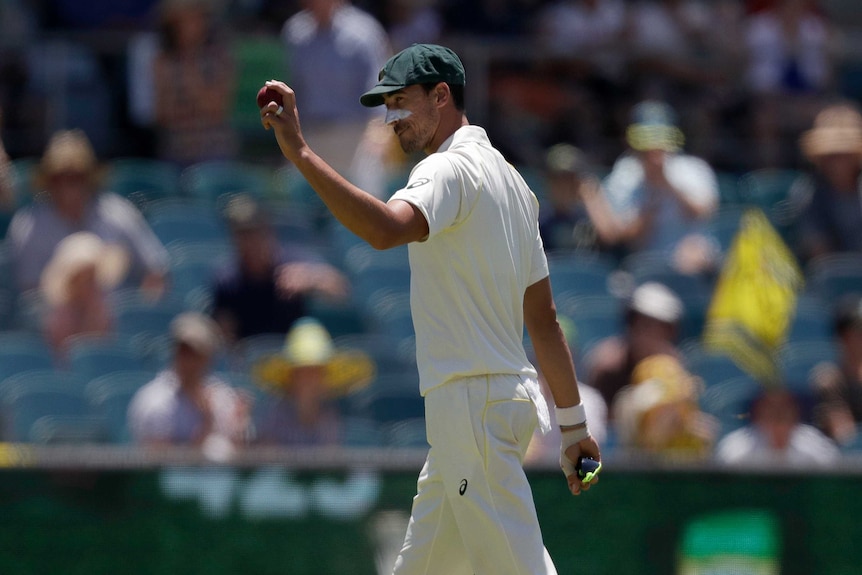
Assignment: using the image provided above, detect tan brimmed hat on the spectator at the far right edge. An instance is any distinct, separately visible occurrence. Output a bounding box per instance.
[799,104,862,160]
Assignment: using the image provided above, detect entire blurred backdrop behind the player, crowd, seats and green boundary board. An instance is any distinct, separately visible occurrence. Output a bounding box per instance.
[0,0,862,575]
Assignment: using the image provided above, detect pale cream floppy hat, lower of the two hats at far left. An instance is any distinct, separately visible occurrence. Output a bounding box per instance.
[40,232,129,305]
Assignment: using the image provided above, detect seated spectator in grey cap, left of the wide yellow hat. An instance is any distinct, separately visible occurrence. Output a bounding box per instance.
[128,312,249,453]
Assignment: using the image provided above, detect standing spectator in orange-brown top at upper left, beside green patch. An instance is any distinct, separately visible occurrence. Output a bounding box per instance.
[153,0,237,166]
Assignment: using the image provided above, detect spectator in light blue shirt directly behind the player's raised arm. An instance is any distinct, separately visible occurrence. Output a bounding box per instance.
[282,0,391,179]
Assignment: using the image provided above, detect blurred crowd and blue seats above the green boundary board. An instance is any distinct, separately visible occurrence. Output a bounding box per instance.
[0,0,862,465]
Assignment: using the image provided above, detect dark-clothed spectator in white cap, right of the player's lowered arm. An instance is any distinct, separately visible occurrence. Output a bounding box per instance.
[587,282,683,408]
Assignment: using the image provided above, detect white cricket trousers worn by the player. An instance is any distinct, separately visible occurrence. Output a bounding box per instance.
[393,375,557,575]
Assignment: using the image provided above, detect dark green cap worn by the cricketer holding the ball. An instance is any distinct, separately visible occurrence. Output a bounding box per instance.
[359,44,465,108]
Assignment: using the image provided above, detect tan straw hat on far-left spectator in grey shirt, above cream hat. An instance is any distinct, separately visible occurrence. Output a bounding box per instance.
[33,130,104,190]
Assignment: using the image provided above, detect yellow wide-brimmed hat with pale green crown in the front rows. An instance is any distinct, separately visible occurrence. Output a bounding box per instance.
[253,317,375,396]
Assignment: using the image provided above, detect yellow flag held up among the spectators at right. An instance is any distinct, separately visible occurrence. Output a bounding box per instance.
[704,208,803,383]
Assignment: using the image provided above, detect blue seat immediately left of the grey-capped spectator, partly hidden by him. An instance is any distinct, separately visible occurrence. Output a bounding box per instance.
[84,370,157,443]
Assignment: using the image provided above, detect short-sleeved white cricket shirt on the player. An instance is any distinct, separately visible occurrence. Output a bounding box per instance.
[390,126,548,396]
